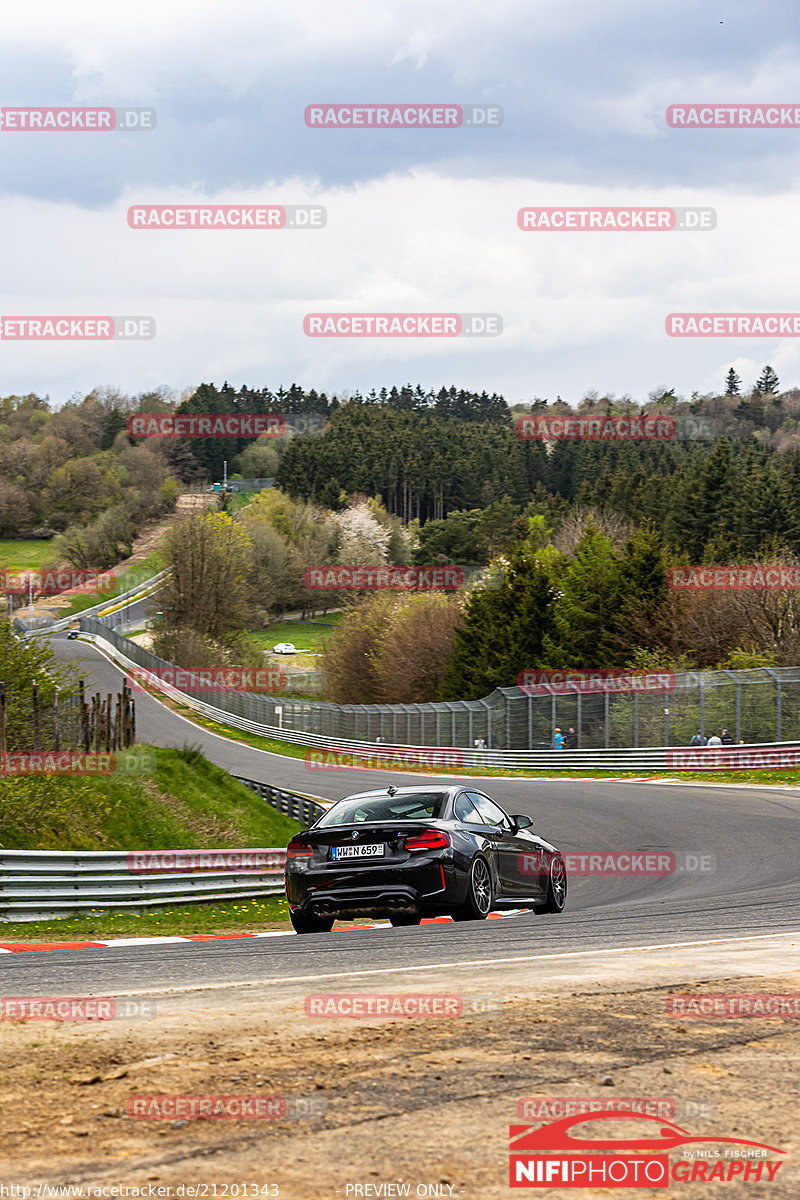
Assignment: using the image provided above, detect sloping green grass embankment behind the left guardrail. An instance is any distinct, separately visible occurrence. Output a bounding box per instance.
[0,748,300,850]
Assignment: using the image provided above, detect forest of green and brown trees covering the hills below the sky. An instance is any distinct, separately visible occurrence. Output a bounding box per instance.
[0,367,800,702]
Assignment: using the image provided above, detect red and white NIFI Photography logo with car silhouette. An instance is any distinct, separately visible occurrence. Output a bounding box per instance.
[509,1111,786,1189]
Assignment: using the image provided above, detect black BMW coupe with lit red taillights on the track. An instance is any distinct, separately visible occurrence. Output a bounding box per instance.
[285,785,566,934]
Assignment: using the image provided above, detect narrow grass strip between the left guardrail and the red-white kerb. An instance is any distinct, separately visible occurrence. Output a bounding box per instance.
[0,895,290,944]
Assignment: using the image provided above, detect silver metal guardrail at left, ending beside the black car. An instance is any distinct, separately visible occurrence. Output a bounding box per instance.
[0,776,324,922]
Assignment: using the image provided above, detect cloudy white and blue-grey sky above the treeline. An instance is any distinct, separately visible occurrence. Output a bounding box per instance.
[0,0,800,403]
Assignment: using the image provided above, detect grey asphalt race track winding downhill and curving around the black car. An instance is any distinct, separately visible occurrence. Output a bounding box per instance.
[6,635,800,995]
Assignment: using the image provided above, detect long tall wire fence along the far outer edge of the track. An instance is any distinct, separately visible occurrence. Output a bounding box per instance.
[80,619,800,752]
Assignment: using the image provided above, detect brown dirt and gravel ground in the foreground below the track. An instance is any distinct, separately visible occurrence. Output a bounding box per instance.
[0,955,800,1200]
